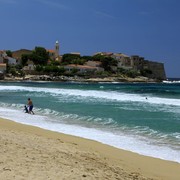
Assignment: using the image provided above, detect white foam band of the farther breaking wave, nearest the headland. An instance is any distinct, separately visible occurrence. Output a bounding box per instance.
[0,86,180,106]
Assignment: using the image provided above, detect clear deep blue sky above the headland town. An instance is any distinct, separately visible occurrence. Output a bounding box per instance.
[0,0,180,78]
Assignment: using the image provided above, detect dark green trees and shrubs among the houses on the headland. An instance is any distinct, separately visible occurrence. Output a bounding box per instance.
[6,47,155,78]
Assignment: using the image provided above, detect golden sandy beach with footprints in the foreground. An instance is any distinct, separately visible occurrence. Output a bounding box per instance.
[0,119,180,180]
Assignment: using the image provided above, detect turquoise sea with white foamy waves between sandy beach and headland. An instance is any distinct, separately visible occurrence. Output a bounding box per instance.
[0,82,180,163]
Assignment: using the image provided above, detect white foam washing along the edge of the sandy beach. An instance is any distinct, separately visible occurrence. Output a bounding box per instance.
[0,107,180,163]
